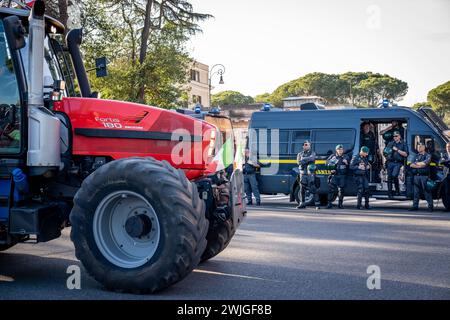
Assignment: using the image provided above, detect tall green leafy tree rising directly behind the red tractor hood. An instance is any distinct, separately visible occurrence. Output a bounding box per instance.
[78,0,210,107]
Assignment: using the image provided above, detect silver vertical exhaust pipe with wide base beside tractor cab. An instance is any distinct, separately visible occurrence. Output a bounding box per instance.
[27,0,61,175]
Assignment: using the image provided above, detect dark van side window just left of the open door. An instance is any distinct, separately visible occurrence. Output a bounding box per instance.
[313,129,355,156]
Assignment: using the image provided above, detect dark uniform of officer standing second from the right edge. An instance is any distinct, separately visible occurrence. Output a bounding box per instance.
[411,152,433,210]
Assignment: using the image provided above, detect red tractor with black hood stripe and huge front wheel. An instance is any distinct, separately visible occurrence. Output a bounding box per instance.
[0,0,245,293]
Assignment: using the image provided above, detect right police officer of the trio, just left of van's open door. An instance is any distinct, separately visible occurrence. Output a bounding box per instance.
[350,147,370,210]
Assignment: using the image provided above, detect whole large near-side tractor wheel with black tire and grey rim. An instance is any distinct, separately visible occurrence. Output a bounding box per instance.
[70,158,208,293]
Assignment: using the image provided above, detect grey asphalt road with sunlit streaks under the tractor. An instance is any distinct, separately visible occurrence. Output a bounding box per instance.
[0,197,450,300]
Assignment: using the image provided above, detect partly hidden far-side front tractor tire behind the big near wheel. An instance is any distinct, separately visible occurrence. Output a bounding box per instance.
[202,220,236,262]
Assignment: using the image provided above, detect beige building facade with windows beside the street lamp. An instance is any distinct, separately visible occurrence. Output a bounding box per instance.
[188,61,210,109]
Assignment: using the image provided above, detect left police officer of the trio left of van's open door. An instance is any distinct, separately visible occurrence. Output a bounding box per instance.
[297,140,320,209]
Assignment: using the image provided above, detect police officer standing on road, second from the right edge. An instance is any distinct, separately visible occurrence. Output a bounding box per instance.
[409,142,433,212]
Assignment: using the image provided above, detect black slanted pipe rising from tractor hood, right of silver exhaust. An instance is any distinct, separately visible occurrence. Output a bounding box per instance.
[66,29,92,98]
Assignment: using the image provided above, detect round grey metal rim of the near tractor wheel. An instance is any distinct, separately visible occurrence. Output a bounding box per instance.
[93,190,161,269]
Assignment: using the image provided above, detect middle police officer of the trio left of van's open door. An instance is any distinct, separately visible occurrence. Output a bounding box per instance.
[327,144,350,209]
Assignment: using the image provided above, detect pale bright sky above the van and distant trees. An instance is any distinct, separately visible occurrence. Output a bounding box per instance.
[188,0,450,105]
